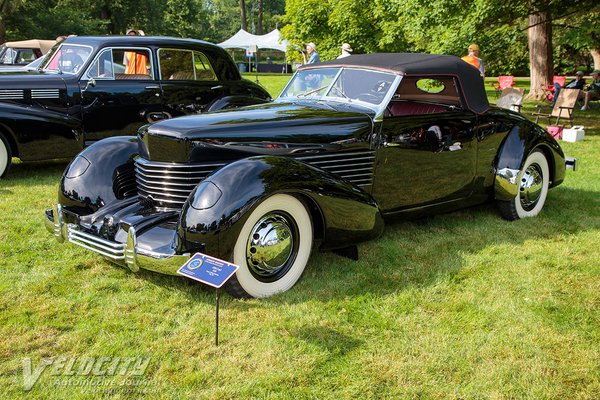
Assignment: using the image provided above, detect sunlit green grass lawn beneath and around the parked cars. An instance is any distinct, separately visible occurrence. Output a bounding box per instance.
[0,76,600,399]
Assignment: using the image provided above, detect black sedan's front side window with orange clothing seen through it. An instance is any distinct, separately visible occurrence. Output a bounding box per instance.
[87,49,154,80]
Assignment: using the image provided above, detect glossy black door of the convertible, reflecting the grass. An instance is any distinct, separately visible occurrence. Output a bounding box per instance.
[373,76,477,213]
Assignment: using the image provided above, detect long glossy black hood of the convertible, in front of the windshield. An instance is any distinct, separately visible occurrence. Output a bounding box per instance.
[139,102,373,163]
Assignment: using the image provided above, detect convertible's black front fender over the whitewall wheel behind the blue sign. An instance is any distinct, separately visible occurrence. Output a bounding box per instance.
[178,156,383,259]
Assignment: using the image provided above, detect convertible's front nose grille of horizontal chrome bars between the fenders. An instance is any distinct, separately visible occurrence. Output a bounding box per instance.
[135,157,225,207]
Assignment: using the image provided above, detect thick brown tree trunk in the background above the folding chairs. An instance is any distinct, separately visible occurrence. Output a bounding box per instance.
[527,11,553,100]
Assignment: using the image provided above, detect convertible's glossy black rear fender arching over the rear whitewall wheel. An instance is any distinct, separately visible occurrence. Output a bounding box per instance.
[494,122,565,201]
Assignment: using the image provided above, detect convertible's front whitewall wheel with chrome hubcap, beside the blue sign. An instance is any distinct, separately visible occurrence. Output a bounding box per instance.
[227,194,313,298]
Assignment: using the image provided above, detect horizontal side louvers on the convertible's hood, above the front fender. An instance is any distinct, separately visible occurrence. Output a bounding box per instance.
[294,150,375,186]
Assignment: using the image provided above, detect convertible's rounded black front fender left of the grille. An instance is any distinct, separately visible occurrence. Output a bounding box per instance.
[58,136,138,215]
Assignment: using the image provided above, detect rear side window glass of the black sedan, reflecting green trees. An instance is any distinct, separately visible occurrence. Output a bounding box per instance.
[158,49,217,81]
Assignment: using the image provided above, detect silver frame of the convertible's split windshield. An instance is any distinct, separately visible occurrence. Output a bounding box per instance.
[274,66,402,116]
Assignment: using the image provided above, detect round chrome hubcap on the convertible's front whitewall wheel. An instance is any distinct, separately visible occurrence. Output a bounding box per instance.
[246,212,297,281]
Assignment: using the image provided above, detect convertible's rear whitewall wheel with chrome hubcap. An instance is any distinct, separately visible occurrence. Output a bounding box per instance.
[498,150,550,221]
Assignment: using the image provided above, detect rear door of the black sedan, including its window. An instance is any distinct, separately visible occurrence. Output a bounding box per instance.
[158,48,224,117]
